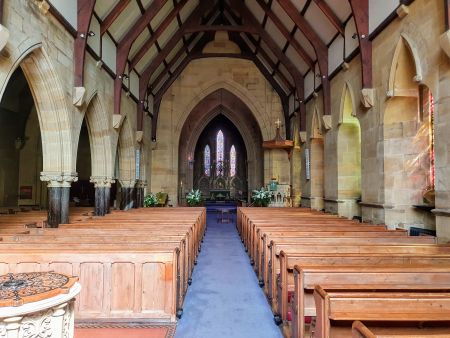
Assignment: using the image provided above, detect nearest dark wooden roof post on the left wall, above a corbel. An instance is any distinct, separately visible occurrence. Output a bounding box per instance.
[73,0,95,87]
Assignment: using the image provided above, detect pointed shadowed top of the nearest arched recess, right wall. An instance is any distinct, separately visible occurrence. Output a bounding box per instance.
[388,33,423,97]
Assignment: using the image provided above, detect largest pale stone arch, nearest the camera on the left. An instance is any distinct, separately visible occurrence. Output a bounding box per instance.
[1,42,76,176]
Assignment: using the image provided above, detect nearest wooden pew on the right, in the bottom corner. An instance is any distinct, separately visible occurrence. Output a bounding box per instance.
[313,285,450,338]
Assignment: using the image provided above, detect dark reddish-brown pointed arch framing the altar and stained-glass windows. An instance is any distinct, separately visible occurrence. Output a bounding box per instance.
[178,88,263,202]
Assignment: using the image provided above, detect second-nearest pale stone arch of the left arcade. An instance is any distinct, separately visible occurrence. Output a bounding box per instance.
[84,93,114,178]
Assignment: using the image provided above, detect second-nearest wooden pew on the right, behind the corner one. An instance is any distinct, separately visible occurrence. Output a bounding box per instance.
[292,261,450,338]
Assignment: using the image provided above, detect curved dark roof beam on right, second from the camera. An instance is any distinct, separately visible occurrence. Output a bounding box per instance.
[277,0,331,115]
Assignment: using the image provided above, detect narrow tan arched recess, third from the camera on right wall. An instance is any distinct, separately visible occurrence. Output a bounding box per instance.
[309,107,325,210]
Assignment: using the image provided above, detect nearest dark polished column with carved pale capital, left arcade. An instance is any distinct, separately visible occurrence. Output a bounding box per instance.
[41,172,78,228]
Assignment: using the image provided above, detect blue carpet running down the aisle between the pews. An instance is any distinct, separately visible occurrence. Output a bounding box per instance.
[175,213,282,338]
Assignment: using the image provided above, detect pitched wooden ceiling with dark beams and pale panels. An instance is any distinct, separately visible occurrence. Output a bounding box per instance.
[75,0,378,138]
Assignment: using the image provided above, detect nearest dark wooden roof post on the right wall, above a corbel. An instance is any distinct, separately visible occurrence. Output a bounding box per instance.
[350,0,373,88]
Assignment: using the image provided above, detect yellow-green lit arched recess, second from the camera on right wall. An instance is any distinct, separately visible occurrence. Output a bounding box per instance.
[337,83,361,218]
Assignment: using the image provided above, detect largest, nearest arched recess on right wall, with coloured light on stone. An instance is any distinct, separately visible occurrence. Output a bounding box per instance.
[383,35,435,228]
